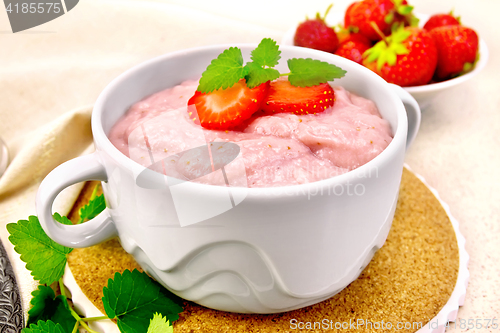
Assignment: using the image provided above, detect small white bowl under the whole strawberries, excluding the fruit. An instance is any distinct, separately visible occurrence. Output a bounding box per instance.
[281,12,489,109]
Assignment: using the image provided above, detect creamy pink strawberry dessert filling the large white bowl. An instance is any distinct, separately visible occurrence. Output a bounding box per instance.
[109,81,392,187]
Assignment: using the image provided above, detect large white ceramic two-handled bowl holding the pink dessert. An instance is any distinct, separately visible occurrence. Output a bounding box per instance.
[37,45,420,313]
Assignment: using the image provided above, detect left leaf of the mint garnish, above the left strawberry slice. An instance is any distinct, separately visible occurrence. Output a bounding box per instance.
[197,47,246,93]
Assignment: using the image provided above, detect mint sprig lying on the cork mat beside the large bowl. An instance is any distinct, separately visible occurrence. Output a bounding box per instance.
[7,187,183,333]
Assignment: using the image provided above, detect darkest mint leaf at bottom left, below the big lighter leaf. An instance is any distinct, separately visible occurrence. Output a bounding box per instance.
[28,285,76,332]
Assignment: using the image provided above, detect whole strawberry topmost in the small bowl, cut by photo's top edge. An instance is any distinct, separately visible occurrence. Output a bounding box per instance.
[344,0,418,41]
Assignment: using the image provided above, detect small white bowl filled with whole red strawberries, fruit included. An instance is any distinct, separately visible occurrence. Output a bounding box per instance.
[282,0,488,107]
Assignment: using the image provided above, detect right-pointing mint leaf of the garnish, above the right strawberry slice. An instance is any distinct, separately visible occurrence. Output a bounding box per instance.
[288,58,346,87]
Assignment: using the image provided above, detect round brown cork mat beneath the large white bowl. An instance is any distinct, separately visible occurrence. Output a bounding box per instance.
[68,169,459,333]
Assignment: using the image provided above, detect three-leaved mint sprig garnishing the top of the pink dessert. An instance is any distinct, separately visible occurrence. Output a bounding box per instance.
[197,38,346,93]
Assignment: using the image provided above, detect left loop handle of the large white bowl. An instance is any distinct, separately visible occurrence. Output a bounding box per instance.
[36,153,117,247]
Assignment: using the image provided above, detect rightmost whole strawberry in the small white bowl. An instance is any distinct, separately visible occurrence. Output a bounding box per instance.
[430,25,479,81]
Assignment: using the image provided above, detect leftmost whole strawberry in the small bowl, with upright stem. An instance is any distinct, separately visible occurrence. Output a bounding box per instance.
[293,5,339,53]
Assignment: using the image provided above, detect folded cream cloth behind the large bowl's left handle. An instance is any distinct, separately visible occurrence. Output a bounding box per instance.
[0,106,94,318]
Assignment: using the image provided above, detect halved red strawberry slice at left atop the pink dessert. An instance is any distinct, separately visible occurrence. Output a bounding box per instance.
[188,79,269,130]
